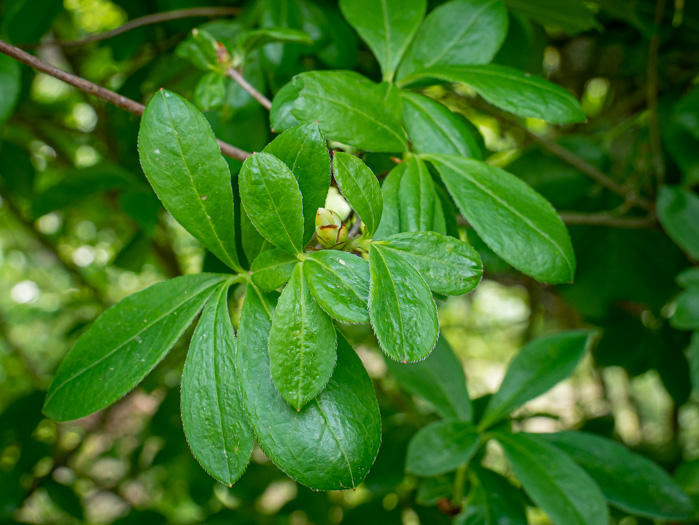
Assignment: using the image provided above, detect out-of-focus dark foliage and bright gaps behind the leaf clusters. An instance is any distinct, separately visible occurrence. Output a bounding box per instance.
[0,0,699,525]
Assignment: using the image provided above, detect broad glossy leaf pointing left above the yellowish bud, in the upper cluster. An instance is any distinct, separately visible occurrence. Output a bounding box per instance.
[291,71,408,152]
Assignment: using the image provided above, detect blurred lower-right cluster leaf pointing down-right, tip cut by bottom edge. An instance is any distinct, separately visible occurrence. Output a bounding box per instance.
[494,433,609,525]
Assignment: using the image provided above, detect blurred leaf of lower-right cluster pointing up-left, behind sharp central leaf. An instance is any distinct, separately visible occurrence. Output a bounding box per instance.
[386,337,473,422]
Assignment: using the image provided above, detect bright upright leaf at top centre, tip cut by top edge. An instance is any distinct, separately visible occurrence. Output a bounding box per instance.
[340,0,427,82]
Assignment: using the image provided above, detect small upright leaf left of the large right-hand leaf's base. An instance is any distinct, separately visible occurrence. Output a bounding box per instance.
[398,157,438,232]
